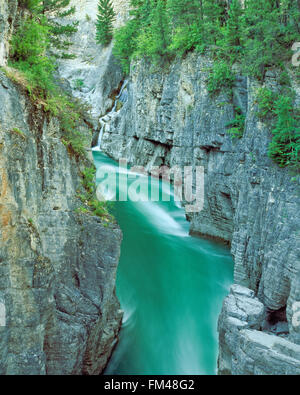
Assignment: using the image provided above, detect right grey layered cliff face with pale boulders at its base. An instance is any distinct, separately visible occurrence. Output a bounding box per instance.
[101,54,300,374]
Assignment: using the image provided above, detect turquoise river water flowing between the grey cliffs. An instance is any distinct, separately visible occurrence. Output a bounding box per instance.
[93,152,233,375]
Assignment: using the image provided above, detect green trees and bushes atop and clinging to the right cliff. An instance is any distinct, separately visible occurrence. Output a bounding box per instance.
[110,0,300,173]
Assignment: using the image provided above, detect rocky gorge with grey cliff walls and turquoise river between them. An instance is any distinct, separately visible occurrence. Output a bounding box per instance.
[0,0,300,376]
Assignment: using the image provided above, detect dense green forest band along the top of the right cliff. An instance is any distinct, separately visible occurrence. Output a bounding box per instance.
[115,0,300,80]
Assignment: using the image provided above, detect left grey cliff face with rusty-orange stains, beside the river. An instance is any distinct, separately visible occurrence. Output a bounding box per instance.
[0,69,122,374]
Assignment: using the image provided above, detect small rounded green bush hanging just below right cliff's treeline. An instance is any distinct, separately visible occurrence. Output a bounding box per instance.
[208,61,234,93]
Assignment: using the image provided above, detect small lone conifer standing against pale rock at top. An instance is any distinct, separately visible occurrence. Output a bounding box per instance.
[96,0,116,45]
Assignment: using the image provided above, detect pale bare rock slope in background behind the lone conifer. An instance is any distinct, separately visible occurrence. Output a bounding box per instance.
[58,0,129,121]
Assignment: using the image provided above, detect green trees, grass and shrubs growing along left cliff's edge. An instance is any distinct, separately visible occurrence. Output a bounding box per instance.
[8,0,112,223]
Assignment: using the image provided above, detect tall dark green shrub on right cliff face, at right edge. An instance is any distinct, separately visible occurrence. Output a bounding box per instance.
[269,96,300,171]
